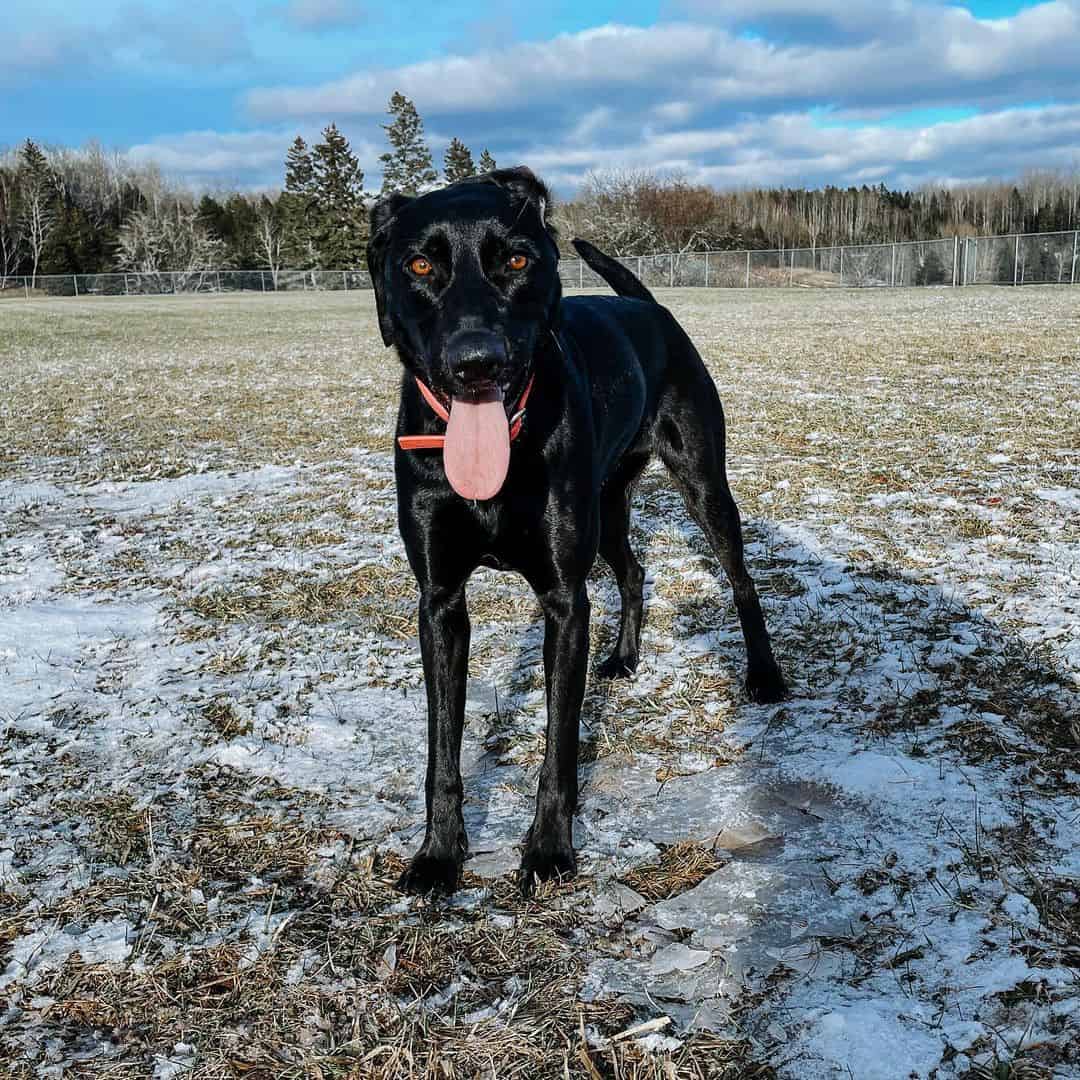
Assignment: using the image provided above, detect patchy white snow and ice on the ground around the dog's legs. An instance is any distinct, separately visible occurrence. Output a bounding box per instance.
[0,461,1078,1077]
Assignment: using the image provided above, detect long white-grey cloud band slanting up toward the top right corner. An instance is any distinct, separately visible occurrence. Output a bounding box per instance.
[246,0,1080,118]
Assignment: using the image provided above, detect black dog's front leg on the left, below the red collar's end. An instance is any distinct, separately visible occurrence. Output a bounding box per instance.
[397,582,470,893]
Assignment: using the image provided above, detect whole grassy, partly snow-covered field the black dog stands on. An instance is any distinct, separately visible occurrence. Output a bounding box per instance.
[0,287,1080,1080]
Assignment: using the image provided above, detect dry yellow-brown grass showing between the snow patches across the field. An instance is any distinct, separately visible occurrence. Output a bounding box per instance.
[0,289,1080,1080]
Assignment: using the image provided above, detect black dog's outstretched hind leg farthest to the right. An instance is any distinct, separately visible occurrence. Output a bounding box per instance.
[656,362,787,702]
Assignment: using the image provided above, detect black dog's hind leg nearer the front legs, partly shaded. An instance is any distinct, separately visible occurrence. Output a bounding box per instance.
[598,454,649,678]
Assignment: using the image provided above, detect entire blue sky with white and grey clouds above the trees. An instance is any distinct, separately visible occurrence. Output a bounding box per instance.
[0,0,1080,193]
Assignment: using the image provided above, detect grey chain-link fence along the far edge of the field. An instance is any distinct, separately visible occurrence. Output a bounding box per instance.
[0,231,1080,299]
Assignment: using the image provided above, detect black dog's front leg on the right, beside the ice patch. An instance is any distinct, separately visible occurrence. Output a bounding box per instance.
[519,581,589,896]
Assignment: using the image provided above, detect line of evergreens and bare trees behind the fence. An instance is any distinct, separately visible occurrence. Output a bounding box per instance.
[0,93,1080,278]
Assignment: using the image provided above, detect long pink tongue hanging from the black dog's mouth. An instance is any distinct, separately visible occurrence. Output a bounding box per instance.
[443,392,510,499]
